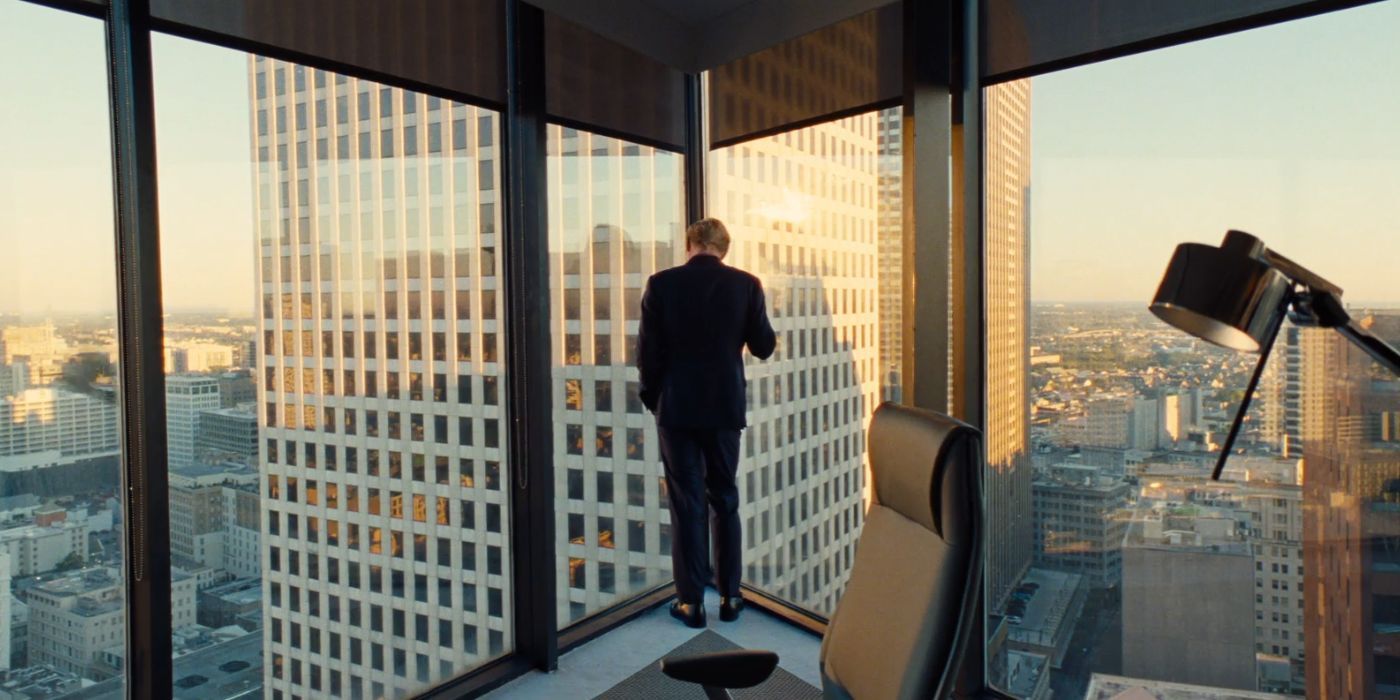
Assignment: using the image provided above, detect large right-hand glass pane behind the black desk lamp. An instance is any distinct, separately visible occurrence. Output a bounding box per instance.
[986,3,1400,699]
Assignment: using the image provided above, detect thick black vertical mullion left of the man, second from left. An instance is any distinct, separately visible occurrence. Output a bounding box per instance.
[500,0,559,671]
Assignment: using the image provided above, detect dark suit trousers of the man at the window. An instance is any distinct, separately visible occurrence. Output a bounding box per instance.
[657,426,743,603]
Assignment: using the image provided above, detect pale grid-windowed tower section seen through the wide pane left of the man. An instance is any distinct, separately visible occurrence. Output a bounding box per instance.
[254,57,512,697]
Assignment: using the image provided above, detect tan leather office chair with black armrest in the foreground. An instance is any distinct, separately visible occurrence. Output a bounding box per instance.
[661,403,983,700]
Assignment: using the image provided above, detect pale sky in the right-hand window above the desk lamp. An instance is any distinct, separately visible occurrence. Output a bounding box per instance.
[1030,0,1400,302]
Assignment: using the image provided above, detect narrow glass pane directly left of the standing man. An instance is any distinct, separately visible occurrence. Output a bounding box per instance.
[549,126,685,626]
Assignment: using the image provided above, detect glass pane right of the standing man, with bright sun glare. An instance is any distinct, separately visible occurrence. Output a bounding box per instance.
[710,111,903,615]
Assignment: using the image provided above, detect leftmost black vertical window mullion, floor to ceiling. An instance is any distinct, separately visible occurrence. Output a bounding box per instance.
[106,0,172,697]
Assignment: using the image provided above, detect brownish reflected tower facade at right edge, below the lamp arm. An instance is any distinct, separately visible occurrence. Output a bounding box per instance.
[1302,314,1400,699]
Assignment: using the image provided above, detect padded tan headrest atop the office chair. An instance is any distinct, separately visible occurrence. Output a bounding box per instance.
[869,402,979,539]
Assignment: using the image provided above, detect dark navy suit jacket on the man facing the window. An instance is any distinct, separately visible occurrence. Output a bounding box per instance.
[637,255,777,430]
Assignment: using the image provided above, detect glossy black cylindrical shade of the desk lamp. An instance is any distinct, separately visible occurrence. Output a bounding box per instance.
[1149,231,1292,353]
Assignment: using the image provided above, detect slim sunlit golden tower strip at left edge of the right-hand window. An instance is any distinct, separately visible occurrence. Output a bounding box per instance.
[983,80,1035,608]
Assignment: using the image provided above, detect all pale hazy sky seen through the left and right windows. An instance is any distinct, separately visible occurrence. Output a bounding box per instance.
[0,0,1400,315]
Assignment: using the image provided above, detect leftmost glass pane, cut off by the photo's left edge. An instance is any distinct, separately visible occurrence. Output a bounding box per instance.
[0,1,126,696]
